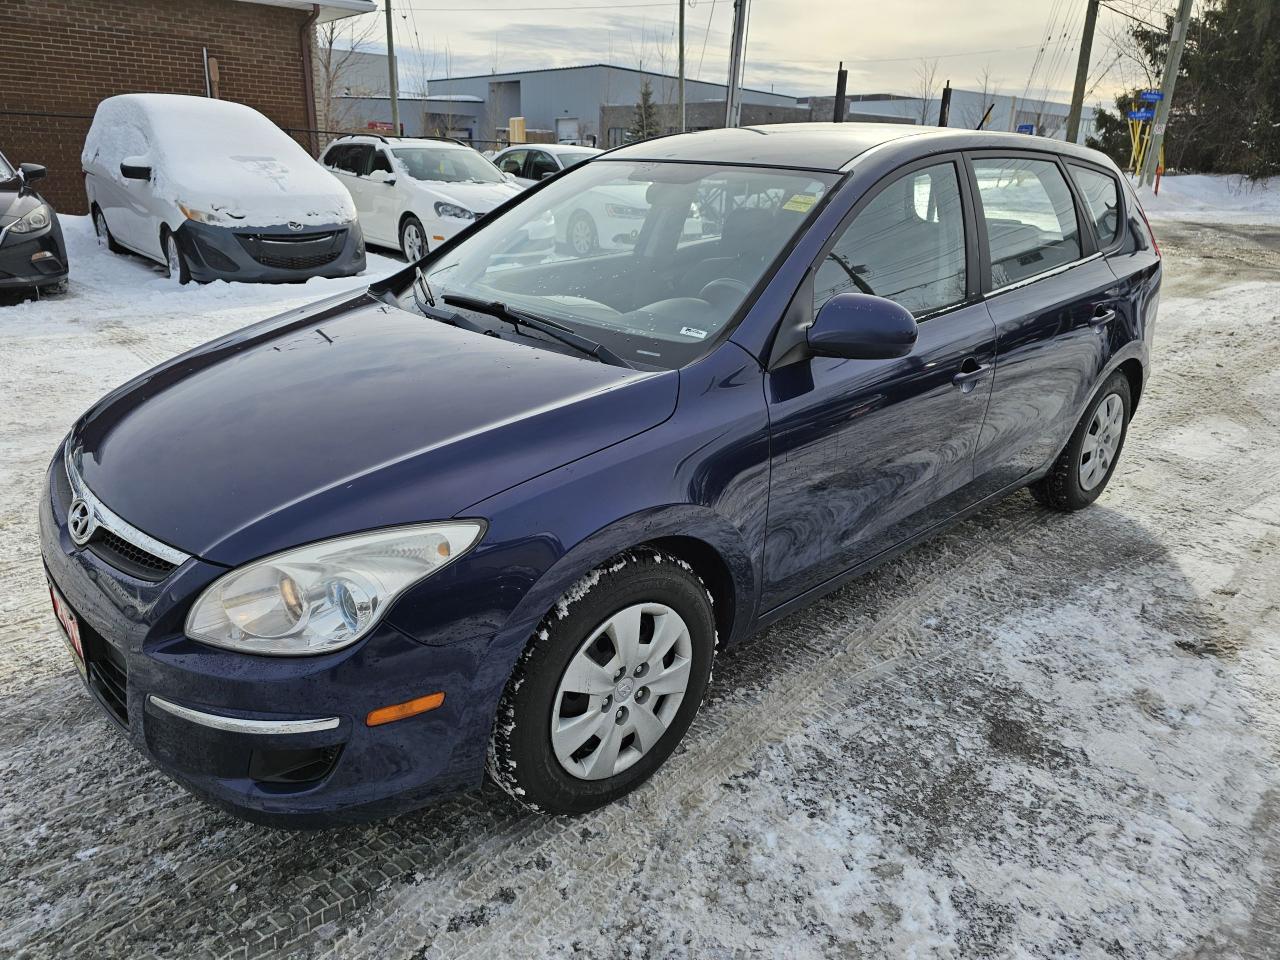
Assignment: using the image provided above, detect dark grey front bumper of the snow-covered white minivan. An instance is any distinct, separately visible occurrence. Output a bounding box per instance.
[174,220,365,283]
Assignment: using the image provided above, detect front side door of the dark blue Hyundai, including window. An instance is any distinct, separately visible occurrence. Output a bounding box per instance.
[762,157,996,611]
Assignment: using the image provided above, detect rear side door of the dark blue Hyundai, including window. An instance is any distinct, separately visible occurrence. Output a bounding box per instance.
[968,151,1120,493]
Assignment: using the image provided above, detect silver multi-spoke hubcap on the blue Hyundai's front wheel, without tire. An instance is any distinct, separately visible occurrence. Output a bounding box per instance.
[550,603,692,780]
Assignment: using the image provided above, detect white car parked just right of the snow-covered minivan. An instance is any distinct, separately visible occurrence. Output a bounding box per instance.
[320,133,529,261]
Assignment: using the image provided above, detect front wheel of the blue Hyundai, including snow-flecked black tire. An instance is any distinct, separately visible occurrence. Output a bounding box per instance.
[489,552,716,813]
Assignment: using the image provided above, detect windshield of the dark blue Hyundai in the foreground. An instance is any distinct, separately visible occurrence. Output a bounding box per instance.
[414,160,838,369]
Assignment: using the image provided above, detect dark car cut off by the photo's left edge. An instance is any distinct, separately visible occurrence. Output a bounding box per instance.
[0,154,67,293]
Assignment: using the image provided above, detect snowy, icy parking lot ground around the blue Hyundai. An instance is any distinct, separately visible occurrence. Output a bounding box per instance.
[0,216,1280,960]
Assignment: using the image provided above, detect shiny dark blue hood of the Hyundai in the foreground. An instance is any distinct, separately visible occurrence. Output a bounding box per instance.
[70,294,678,566]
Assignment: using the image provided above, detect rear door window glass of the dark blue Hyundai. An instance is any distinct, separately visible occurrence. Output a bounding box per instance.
[973,157,1080,289]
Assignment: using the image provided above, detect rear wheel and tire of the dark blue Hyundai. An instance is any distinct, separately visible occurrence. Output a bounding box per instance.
[1030,371,1133,511]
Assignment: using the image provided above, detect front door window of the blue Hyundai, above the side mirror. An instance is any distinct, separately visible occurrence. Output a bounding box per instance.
[813,163,965,316]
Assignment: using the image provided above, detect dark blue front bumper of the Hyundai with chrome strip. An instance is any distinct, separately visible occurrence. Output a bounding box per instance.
[40,453,492,828]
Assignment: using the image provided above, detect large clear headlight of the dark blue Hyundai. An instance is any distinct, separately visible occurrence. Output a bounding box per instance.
[186,520,484,657]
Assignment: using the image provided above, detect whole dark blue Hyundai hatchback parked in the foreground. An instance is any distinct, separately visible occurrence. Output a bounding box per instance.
[40,124,1161,826]
